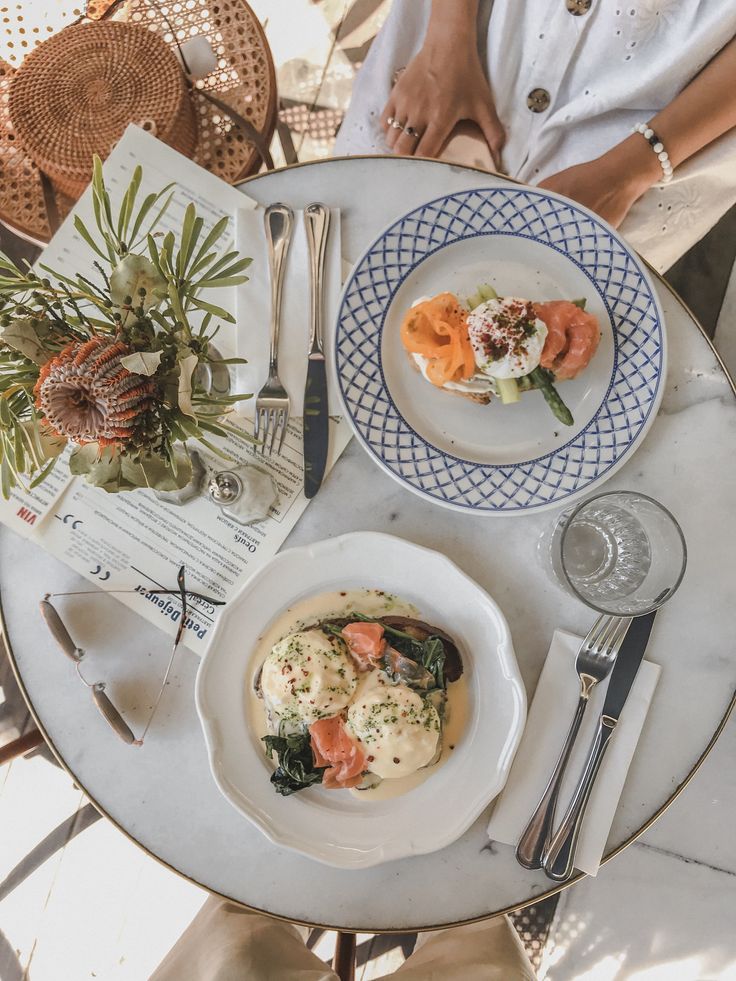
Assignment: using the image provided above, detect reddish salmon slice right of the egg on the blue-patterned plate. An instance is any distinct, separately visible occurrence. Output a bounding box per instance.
[534,300,601,381]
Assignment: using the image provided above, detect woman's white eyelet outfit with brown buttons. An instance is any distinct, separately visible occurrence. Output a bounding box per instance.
[335,0,736,270]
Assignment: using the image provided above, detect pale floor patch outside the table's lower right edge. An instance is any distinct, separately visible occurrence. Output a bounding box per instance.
[539,719,736,981]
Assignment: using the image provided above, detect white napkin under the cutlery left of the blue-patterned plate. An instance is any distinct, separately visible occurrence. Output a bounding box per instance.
[235,205,342,419]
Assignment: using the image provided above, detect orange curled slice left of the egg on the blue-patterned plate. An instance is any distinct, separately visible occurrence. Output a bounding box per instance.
[401,293,476,386]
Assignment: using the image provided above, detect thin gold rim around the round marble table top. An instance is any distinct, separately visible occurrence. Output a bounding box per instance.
[0,154,736,935]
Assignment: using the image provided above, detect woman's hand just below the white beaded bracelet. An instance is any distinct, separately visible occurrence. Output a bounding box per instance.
[539,134,662,228]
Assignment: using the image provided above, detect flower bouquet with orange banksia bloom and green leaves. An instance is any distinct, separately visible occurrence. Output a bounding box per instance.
[0,159,251,497]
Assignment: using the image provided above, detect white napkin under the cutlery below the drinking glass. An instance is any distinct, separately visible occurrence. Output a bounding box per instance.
[488,630,660,875]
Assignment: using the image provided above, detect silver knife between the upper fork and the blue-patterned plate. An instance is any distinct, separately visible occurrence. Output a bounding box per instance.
[304,204,330,498]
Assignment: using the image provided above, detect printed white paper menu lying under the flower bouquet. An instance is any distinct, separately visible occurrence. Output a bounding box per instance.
[0,127,350,654]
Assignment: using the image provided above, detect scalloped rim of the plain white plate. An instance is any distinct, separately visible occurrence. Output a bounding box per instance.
[194,531,527,871]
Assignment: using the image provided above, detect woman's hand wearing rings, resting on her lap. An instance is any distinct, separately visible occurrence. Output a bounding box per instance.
[381,37,505,168]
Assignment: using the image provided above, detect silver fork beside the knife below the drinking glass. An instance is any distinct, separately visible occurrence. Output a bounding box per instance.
[516,616,631,869]
